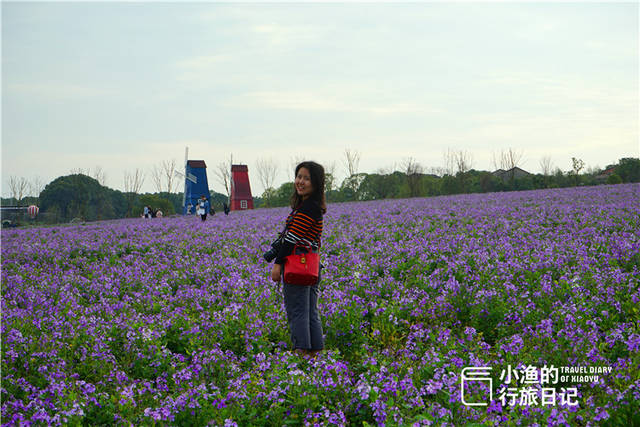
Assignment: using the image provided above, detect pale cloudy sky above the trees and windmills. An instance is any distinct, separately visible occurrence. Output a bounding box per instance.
[1,1,640,197]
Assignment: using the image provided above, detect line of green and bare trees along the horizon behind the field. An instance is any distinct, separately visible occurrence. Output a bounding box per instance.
[2,155,640,223]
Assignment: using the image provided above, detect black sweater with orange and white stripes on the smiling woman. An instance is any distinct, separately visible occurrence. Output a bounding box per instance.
[275,199,322,264]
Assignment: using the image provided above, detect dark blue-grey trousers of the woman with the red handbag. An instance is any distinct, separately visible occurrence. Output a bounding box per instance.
[282,280,324,350]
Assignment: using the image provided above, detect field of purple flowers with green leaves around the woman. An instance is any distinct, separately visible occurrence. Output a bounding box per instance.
[1,184,640,426]
